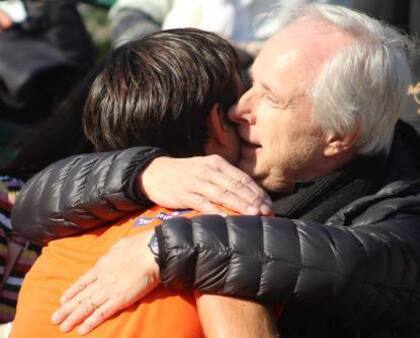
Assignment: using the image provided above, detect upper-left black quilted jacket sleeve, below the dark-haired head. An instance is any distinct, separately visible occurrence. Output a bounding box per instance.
[12,147,163,243]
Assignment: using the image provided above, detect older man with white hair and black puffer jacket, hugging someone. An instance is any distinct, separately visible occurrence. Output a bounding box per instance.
[11,5,420,338]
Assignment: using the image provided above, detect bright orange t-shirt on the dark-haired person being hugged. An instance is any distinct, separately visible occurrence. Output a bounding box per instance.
[10,207,212,338]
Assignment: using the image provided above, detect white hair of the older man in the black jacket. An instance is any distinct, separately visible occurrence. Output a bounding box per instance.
[274,4,414,155]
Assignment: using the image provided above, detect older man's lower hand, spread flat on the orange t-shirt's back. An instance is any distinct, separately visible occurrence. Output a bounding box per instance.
[51,230,159,334]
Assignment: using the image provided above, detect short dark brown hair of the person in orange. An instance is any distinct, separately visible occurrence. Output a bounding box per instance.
[84,29,239,156]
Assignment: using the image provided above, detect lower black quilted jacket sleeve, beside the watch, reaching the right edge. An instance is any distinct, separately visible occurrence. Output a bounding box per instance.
[156,213,420,327]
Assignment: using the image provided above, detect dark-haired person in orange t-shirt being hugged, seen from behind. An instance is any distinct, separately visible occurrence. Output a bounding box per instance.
[11,29,273,338]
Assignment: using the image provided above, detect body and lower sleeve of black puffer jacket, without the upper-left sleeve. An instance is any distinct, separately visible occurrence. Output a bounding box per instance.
[156,125,420,338]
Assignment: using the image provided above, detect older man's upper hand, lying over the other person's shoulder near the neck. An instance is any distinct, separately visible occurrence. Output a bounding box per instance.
[139,155,271,215]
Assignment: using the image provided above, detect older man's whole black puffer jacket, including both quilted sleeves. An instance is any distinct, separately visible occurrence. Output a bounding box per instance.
[13,123,420,338]
